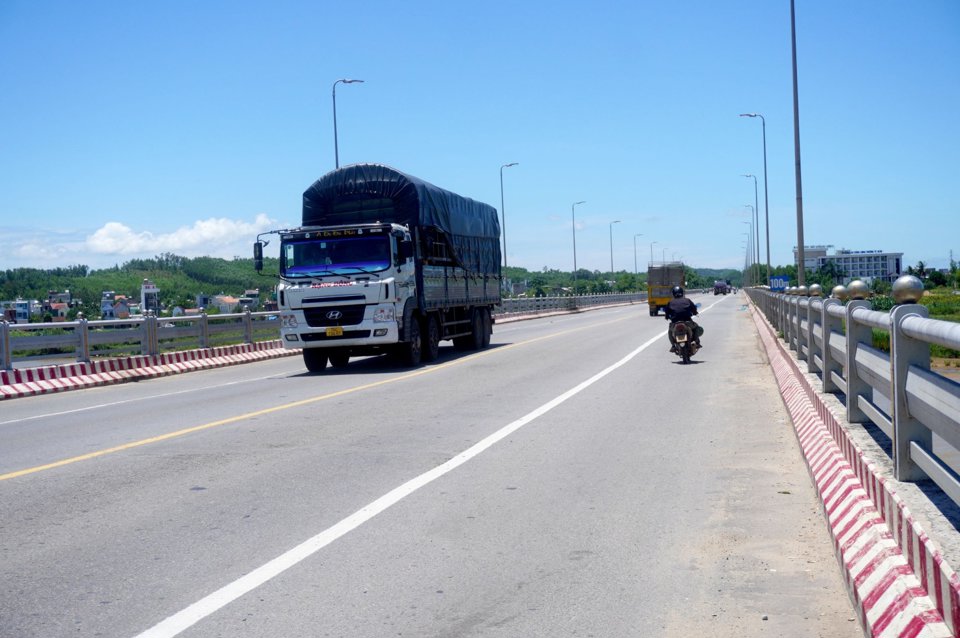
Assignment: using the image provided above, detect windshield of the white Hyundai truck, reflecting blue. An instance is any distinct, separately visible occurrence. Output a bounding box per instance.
[280,235,390,277]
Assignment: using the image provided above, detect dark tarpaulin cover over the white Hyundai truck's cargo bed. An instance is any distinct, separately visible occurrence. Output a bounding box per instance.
[303,164,501,275]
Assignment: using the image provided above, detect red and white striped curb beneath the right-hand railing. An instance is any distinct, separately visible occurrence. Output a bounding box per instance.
[751,306,960,638]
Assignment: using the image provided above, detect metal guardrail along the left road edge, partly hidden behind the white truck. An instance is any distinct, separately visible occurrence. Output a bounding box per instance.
[0,293,647,370]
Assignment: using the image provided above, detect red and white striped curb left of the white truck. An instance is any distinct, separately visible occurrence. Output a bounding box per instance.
[0,340,299,399]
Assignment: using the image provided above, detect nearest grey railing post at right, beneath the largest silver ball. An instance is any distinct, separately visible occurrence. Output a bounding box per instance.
[890,304,933,481]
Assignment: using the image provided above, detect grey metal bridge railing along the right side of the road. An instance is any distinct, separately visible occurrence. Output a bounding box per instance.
[747,289,960,503]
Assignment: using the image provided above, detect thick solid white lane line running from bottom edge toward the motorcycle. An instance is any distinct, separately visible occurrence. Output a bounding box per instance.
[136,332,666,638]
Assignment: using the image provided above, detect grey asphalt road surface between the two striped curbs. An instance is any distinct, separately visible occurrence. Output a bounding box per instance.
[0,295,862,638]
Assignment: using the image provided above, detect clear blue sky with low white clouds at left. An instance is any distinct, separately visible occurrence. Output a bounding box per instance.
[0,0,960,271]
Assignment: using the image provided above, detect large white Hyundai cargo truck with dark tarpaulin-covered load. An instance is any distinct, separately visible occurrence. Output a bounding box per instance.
[254,164,502,372]
